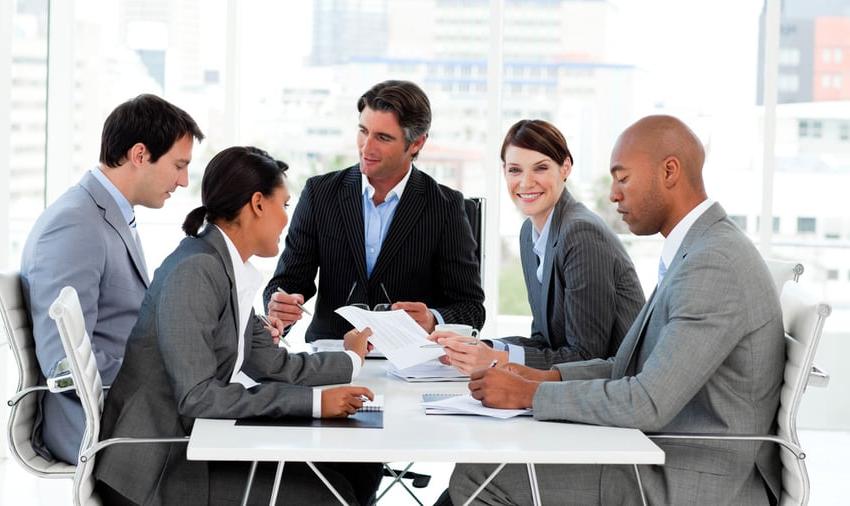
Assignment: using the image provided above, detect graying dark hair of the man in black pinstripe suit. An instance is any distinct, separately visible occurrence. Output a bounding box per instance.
[357,80,431,158]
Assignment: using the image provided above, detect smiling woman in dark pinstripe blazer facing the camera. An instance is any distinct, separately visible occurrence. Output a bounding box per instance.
[431,120,644,373]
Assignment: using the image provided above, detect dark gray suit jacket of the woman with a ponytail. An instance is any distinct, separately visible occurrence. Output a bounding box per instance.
[95,227,352,505]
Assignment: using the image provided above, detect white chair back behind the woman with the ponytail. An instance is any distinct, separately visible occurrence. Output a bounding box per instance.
[50,286,103,506]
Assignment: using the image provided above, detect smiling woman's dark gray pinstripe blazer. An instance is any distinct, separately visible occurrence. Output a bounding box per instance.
[502,190,644,369]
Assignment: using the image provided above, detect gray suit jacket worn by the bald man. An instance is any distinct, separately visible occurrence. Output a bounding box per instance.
[534,204,785,505]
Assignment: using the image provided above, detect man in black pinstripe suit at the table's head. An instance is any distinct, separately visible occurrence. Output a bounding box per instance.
[264,81,484,342]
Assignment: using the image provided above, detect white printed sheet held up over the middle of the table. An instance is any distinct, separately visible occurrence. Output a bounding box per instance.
[336,306,445,369]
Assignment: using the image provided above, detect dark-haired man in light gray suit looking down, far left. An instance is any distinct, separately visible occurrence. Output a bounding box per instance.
[21,95,204,463]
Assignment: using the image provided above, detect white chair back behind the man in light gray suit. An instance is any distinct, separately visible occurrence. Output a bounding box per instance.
[0,272,74,478]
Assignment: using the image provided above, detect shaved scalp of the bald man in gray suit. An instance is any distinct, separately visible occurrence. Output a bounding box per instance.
[617,114,705,193]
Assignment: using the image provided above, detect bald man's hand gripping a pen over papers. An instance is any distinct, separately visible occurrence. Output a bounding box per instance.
[469,367,540,409]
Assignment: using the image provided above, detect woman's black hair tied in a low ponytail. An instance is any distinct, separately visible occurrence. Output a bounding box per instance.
[183,146,289,236]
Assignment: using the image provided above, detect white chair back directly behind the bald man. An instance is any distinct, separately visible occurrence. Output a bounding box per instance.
[777,281,832,506]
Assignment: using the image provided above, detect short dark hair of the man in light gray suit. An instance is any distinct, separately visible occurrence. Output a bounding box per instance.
[100,94,204,167]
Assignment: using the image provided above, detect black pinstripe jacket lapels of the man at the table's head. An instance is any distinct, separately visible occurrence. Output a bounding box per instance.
[370,167,425,279]
